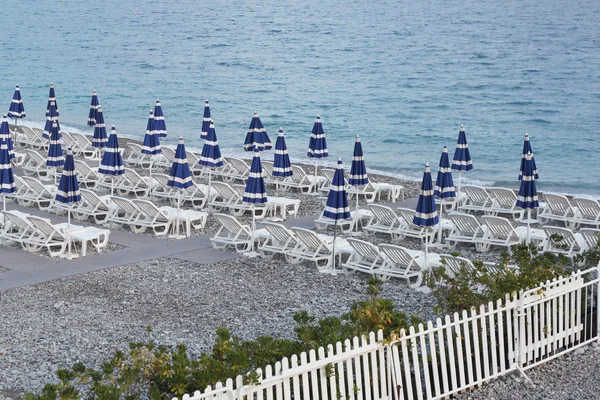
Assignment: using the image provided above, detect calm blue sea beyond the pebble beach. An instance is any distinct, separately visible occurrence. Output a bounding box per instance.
[0,0,600,195]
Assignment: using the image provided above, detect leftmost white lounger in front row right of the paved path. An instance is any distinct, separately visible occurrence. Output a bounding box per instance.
[210,213,267,253]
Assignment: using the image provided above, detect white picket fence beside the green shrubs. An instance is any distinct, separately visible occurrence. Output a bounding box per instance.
[173,264,600,400]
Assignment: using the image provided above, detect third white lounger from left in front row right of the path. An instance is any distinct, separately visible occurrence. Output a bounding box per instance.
[288,228,349,272]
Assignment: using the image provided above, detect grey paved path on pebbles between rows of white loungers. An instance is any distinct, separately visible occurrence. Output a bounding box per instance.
[0,195,416,290]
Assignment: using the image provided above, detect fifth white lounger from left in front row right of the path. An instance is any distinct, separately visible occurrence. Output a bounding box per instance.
[375,244,439,288]
